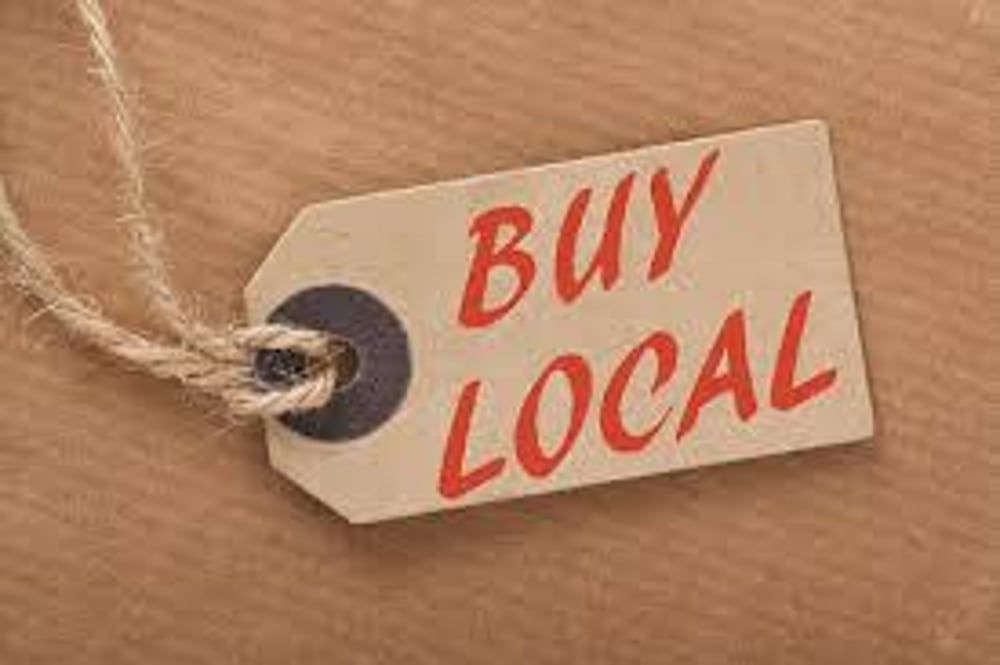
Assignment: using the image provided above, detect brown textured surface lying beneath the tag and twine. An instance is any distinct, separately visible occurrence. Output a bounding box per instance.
[0,0,1000,663]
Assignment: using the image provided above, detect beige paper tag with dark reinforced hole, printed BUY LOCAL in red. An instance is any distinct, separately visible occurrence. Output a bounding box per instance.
[246,121,873,522]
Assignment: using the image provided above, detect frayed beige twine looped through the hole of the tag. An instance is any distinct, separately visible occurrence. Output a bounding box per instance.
[0,0,344,416]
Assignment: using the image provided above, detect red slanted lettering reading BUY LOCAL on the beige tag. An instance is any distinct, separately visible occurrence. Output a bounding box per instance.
[438,150,836,499]
